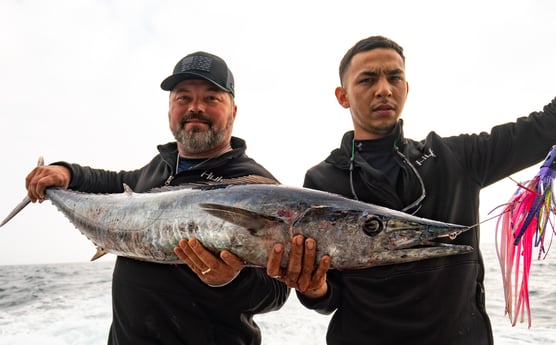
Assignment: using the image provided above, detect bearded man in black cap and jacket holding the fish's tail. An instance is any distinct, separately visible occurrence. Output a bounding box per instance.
[26,52,289,345]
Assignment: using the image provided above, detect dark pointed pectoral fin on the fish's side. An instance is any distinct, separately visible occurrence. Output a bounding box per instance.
[199,203,283,235]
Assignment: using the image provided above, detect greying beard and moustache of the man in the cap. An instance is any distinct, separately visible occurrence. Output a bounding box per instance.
[172,114,229,153]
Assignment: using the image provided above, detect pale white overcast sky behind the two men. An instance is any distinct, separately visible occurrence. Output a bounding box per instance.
[0,0,556,265]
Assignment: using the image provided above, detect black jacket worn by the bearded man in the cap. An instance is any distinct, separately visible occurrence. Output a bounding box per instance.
[54,137,289,345]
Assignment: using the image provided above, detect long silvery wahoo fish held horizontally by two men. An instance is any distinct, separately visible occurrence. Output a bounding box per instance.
[0,177,473,269]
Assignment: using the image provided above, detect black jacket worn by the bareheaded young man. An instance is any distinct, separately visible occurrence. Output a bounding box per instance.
[297,99,556,345]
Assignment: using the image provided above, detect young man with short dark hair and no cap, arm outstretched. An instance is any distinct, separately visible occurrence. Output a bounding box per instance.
[267,36,556,345]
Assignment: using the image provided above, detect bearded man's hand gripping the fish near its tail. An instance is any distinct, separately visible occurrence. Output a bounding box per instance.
[25,165,71,202]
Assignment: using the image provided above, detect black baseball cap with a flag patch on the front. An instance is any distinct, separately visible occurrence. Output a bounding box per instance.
[160,51,234,96]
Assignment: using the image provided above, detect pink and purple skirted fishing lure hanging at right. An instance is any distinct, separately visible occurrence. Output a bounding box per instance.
[496,145,556,328]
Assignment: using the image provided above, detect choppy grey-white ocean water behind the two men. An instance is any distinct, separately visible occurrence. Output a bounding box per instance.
[0,244,556,345]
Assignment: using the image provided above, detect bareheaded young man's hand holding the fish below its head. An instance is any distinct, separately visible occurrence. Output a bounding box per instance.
[266,235,330,298]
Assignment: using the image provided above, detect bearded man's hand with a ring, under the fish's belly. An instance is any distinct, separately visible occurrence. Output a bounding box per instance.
[174,238,243,287]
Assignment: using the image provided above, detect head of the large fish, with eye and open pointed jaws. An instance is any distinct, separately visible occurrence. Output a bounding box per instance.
[296,205,473,269]
